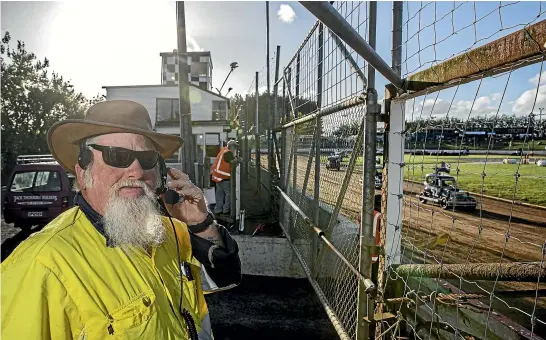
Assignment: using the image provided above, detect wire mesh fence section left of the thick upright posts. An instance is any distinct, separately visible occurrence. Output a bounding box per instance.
[279,3,376,338]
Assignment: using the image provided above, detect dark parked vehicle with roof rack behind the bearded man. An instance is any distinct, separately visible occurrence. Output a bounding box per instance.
[2,155,74,229]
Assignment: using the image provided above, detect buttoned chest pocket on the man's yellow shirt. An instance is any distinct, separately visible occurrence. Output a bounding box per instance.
[108,292,157,339]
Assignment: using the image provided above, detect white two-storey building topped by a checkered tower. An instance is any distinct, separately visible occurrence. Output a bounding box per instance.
[103,52,229,163]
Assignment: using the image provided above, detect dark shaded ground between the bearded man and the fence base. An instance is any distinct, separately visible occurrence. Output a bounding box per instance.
[206,276,338,340]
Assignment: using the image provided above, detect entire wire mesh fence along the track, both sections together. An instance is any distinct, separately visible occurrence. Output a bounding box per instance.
[242,2,546,339]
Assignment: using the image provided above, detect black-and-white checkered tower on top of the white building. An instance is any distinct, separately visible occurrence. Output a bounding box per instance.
[159,50,212,91]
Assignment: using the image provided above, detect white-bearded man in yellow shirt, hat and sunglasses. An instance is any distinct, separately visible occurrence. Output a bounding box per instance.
[1,100,241,340]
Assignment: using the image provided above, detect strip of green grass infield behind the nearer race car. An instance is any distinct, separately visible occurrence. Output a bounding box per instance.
[404,162,546,206]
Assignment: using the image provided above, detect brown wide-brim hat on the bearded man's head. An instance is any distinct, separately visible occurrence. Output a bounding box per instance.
[47,100,184,175]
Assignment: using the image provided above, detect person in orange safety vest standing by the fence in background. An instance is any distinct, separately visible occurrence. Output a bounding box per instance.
[210,140,237,215]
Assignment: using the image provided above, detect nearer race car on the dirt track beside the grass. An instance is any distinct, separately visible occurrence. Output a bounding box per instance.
[418,171,477,210]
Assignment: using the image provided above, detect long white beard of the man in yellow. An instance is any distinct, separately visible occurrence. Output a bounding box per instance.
[103,180,165,250]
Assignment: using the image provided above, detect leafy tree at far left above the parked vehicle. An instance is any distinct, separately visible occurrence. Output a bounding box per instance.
[0,32,105,182]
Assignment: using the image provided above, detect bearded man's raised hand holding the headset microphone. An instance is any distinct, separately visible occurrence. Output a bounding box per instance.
[161,168,208,225]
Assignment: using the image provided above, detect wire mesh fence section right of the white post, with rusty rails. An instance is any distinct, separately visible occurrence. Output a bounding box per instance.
[383,2,546,339]
